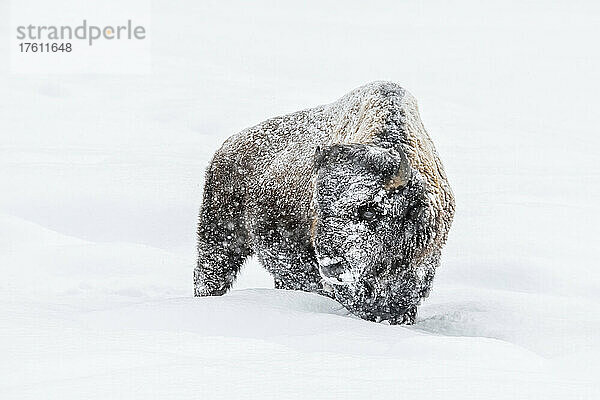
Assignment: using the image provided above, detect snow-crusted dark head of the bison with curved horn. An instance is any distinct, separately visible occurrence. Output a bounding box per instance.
[312,144,439,324]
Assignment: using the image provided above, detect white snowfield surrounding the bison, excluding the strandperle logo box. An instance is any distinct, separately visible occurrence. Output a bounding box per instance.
[0,0,600,399]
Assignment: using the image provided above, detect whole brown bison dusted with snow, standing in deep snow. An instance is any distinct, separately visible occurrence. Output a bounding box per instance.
[194,82,454,324]
